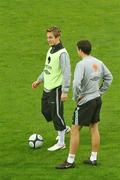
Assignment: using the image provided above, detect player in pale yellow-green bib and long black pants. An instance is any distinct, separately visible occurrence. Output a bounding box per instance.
[32,26,71,151]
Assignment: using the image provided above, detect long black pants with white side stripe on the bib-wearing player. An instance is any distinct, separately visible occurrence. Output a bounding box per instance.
[41,86,66,131]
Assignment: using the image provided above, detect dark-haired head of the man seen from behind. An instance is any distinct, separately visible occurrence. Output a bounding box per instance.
[77,40,92,57]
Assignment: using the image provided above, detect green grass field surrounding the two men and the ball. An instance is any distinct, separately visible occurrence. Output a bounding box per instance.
[0,0,120,180]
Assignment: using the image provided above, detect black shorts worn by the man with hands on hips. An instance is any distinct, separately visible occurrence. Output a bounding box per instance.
[72,97,102,126]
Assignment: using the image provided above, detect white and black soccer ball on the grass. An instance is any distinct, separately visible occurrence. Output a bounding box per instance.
[28,134,43,149]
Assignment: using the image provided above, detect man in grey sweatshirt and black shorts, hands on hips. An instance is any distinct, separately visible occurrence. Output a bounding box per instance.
[56,40,113,169]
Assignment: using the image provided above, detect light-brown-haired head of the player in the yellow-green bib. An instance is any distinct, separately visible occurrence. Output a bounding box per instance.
[47,26,61,46]
